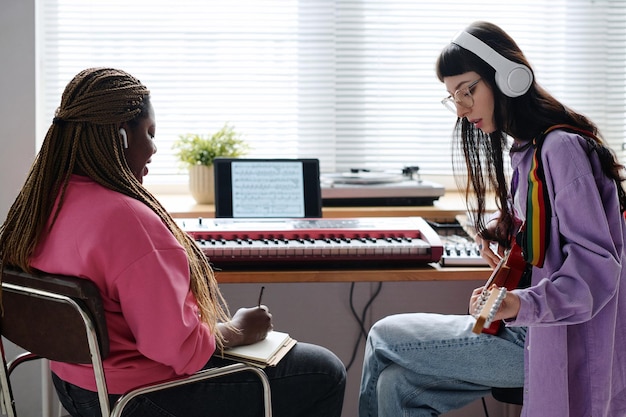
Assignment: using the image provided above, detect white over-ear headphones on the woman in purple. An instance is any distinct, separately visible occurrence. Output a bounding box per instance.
[452,31,533,97]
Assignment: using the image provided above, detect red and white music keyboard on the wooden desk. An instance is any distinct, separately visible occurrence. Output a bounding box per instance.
[176,217,443,269]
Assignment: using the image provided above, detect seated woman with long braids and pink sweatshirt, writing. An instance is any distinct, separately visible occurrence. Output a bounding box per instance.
[0,68,345,417]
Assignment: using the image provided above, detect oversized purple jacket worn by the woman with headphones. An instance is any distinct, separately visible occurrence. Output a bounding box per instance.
[508,130,626,417]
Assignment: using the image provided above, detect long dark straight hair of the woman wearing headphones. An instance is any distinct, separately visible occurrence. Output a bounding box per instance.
[436,22,626,247]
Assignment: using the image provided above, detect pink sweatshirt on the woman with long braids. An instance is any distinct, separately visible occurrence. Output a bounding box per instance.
[31,175,215,394]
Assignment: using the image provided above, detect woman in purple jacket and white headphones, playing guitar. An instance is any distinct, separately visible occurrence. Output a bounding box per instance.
[359,22,626,417]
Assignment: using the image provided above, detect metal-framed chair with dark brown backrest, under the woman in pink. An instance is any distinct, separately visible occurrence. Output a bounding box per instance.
[0,268,272,417]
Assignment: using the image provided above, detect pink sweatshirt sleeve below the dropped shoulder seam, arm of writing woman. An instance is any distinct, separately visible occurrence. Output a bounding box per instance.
[116,250,215,374]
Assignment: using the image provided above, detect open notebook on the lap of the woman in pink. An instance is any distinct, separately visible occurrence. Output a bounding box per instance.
[224,330,297,368]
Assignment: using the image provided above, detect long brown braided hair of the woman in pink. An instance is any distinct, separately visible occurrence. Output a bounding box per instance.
[0,68,228,347]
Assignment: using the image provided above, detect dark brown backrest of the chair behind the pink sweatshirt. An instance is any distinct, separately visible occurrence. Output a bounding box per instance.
[0,268,109,364]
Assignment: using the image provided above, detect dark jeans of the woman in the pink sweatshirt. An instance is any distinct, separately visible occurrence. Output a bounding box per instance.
[52,342,346,417]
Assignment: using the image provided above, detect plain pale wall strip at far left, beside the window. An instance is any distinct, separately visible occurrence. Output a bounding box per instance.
[0,0,41,417]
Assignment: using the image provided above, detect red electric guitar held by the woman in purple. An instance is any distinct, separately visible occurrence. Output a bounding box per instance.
[472,242,526,334]
